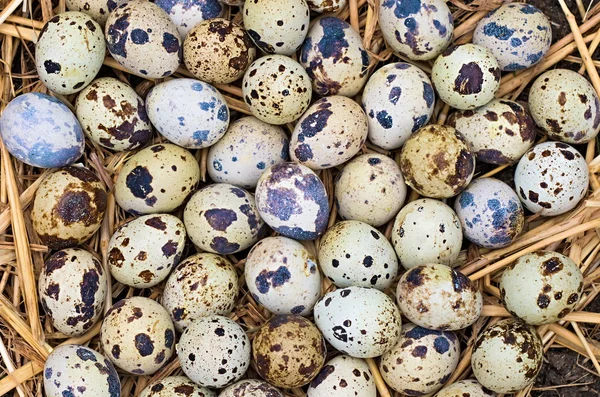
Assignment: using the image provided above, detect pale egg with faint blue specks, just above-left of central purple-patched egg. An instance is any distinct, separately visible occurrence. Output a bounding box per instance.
[207,116,290,189]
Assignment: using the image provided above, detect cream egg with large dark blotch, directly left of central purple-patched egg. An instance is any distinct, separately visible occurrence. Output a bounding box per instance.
[183,183,264,255]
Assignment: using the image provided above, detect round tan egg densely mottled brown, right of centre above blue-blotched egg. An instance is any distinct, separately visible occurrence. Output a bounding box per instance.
[400,124,475,198]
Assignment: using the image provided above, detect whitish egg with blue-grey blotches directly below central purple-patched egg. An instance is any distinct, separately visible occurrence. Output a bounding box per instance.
[244,236,321,316]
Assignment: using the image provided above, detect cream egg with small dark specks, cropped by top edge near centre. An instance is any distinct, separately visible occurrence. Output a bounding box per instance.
[243,0,310,55]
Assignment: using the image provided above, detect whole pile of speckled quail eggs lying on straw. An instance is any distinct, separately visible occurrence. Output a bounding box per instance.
[0,0,600,397]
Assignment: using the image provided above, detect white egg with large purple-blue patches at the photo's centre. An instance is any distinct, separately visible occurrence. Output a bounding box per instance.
[256,163,329,240]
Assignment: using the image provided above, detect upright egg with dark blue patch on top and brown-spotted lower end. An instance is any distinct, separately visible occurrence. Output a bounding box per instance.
[300,17,370,97]
